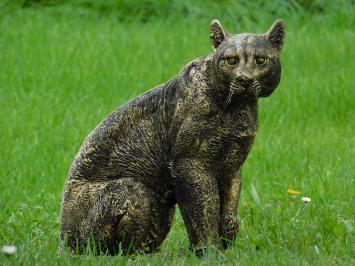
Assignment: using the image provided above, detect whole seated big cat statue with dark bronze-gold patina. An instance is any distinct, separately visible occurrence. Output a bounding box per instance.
[61,20,285,254]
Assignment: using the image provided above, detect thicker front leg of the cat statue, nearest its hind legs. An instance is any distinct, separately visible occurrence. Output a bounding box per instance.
[173,159,222,253]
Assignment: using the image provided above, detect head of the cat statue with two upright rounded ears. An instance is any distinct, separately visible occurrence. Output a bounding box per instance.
[210,20,285,104]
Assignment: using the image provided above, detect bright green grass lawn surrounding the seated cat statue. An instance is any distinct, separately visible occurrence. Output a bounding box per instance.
[0,0,355,265]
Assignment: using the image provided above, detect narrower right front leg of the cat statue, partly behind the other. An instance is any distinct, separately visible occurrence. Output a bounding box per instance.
[219,170,242,248]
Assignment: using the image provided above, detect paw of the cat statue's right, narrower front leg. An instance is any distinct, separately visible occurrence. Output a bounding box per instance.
[219,213,239,248]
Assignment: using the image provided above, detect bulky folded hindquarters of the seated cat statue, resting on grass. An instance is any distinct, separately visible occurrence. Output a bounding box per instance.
[61,179,173,254]
